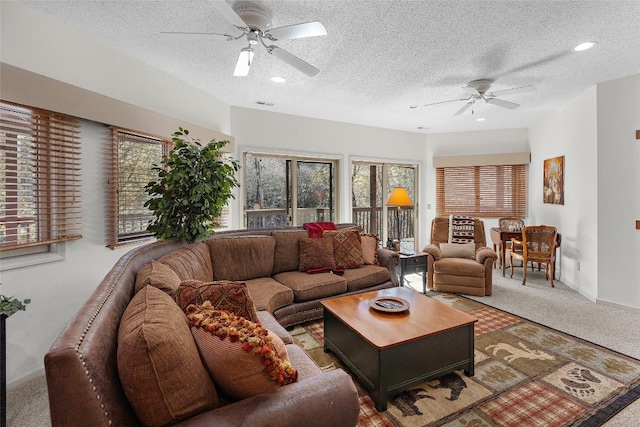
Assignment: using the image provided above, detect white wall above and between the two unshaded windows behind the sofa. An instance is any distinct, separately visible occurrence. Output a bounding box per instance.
[231,107,426,247]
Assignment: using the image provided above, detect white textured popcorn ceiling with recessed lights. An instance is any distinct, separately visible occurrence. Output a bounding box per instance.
[23,0,640,133]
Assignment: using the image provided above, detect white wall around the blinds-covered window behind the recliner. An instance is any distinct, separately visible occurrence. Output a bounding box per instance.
[423,129,530,241]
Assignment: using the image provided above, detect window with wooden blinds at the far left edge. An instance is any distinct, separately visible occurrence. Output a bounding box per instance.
[0,101,82,259]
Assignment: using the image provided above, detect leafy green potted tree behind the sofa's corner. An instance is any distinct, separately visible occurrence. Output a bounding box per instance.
[144,127,240,242]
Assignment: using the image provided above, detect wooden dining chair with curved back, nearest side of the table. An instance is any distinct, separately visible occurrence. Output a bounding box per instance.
[509,225,558,287]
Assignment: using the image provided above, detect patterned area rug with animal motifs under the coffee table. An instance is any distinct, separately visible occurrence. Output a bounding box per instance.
[291,294,640,427]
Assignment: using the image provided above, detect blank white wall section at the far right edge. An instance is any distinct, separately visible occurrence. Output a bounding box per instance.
[596,74,640,308]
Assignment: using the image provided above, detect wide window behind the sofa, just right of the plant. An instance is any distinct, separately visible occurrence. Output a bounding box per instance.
[243,153,337,228]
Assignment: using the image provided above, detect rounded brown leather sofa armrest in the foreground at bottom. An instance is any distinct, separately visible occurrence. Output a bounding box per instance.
[175,369,360,427]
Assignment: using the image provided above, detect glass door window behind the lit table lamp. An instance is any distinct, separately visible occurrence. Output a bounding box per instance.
[351,162,418,251]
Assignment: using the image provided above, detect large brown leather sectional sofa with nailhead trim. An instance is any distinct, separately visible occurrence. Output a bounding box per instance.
[45,224,398,426]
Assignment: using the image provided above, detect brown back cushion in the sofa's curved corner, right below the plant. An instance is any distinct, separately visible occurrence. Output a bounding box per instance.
[158,242,213,282]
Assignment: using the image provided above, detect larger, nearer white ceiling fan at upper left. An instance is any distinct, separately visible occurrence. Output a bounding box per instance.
[161,0,327,77]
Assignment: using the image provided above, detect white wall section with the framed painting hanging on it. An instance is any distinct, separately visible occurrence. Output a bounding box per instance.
[529,87,599,301]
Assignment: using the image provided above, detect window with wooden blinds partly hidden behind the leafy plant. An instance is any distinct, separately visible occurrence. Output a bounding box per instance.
[107,127,171,247]
